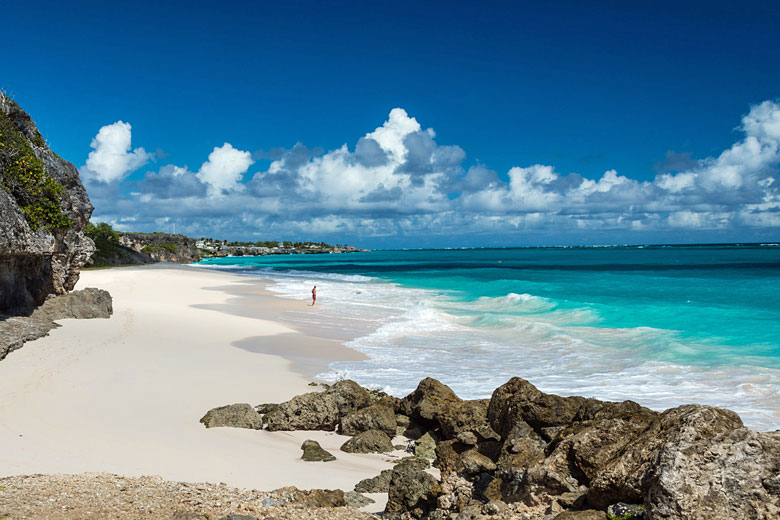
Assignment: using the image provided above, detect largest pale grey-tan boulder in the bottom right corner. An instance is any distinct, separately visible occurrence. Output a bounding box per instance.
[643,424,780,520]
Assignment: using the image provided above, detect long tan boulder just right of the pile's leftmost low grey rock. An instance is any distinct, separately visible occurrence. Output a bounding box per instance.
[265,380,370,431]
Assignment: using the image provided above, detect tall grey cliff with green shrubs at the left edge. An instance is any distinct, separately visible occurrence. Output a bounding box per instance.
[0,93,95,314]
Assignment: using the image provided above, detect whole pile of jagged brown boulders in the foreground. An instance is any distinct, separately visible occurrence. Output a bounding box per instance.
[201,378,780,520]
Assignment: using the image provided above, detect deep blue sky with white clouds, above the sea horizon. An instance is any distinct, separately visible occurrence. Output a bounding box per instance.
[0,0,780,248]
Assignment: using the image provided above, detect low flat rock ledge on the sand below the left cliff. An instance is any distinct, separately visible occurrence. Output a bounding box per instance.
[0,288,113,359]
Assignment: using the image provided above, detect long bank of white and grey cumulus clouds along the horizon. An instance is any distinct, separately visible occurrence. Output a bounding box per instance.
[87,101,780,246]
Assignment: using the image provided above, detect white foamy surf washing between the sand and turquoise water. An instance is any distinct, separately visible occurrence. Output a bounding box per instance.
[229,262,780,430]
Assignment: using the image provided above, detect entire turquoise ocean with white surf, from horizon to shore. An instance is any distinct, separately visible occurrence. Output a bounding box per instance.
[190,244,780,430]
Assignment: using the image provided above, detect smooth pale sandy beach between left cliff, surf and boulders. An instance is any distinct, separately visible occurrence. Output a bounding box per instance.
[0,265,392,490]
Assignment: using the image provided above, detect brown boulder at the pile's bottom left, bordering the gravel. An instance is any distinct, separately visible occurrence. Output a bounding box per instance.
[385,457,440,518]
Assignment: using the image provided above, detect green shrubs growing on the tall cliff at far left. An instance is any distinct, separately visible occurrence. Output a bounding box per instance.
[0,108,73,231]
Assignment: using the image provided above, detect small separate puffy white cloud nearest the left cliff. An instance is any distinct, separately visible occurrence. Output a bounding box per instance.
[81,121,153,183]
